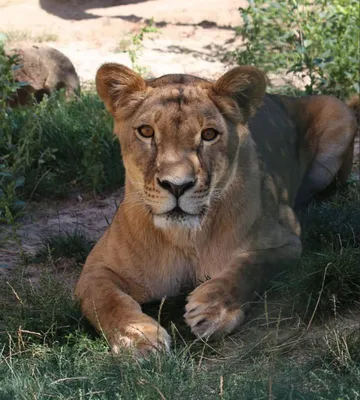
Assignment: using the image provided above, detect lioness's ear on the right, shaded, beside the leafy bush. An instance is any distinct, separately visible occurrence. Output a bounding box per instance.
[213,65,266,121]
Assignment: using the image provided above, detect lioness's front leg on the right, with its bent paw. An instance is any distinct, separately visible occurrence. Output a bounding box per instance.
[185,236,301,338]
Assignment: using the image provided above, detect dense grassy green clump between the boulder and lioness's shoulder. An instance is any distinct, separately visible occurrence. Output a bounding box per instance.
[5,92,123,196]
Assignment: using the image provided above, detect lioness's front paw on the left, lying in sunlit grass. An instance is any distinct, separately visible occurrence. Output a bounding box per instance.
[110,316,171,357]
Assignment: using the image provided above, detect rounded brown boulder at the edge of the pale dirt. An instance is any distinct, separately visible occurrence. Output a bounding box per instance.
[6,45,80,106]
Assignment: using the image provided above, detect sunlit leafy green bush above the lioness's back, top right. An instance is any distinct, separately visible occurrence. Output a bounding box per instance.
[235,0,360,98]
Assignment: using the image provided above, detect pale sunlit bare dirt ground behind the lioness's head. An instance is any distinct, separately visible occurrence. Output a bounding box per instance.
[0,0,246,81]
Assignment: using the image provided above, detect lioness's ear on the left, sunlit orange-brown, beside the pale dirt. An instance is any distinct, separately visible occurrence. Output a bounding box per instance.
[96,63,146,116]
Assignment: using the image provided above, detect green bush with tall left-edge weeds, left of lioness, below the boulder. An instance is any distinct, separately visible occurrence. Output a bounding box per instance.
[0,44,124,223]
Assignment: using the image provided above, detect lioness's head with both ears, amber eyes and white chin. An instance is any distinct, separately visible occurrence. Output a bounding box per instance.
[96,64,266,229]
